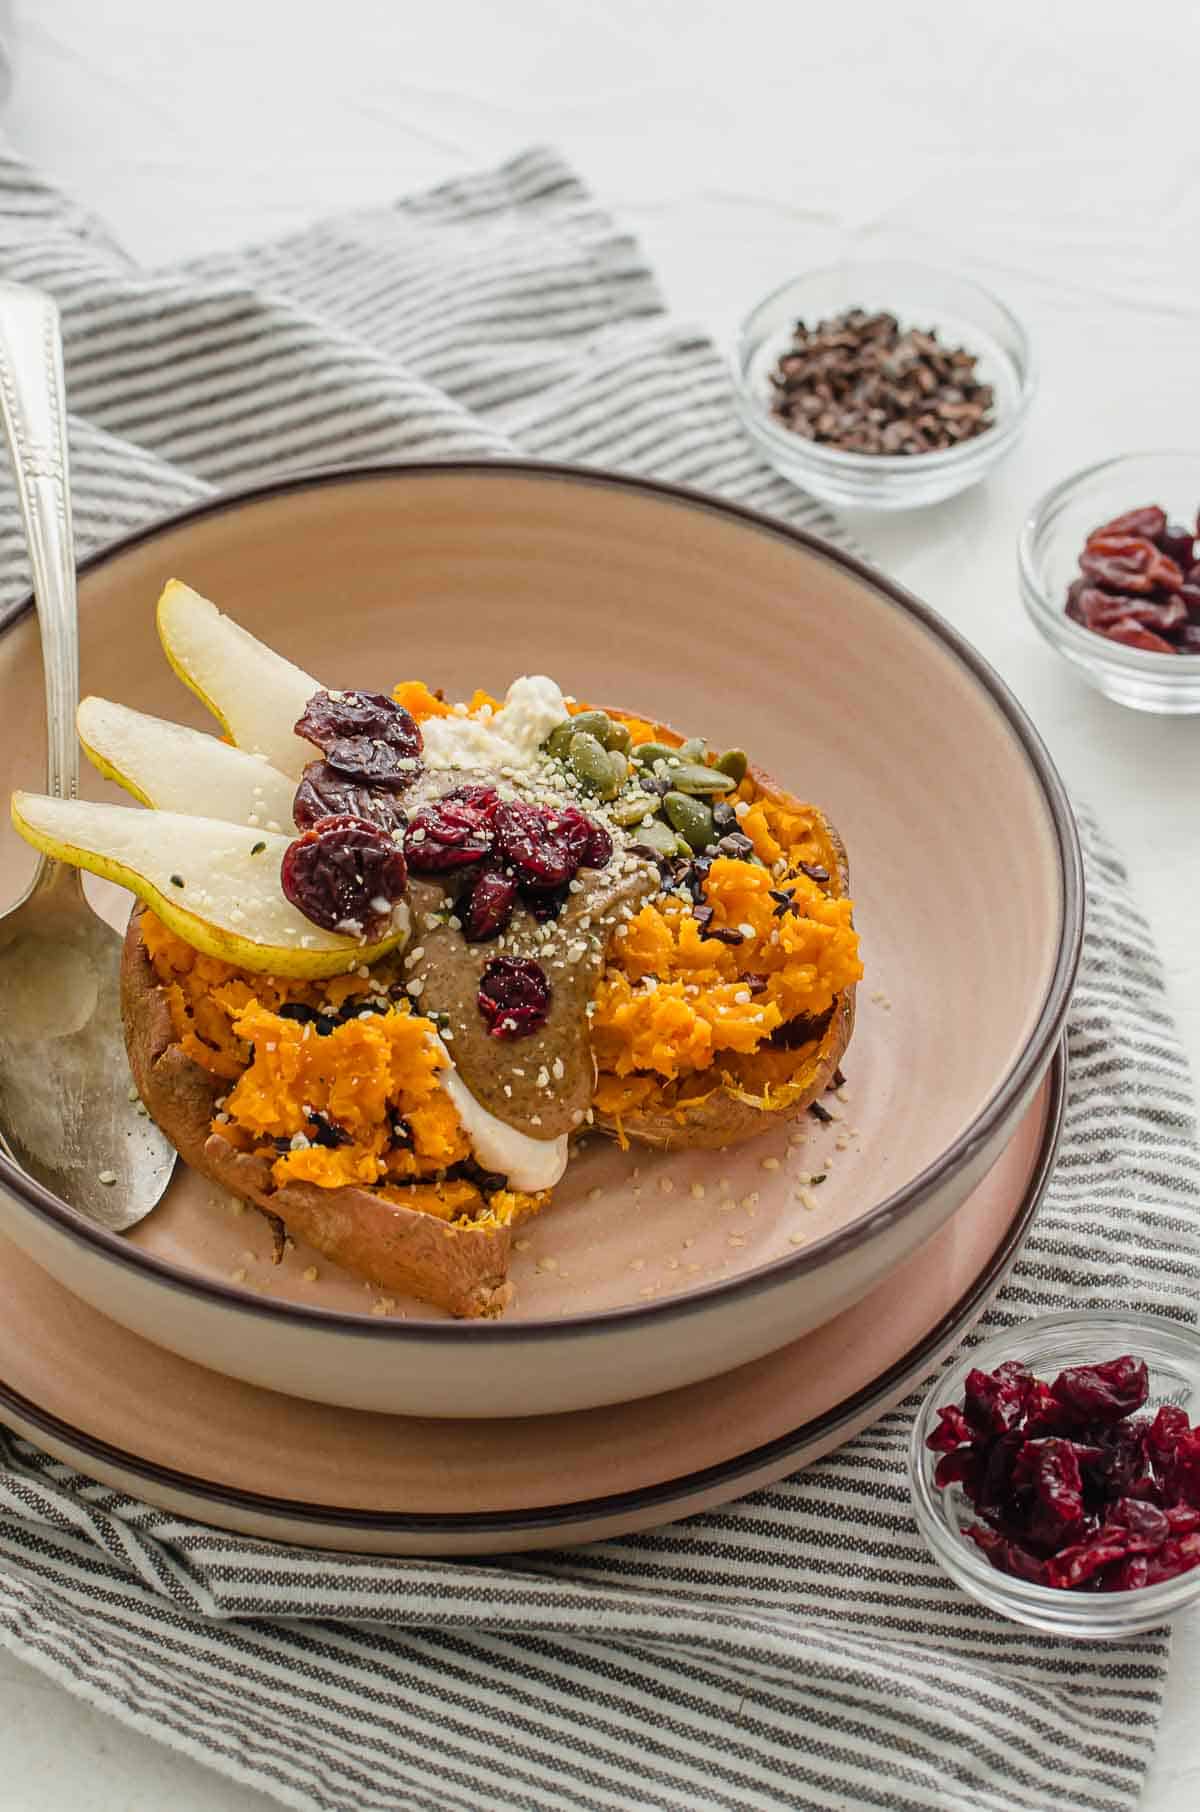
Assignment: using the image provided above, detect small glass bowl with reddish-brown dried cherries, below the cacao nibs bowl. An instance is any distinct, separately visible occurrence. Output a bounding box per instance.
[1017,451,1200,716]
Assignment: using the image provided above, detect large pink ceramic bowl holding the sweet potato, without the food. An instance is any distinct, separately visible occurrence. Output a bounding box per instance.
[0,460,1082,1417]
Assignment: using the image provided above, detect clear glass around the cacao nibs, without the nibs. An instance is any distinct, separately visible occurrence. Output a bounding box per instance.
[734,259,1037,509]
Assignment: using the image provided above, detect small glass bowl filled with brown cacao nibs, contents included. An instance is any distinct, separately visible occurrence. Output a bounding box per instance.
[734,259,1035,509]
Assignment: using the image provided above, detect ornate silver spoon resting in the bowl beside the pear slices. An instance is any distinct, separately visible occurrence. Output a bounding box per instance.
[0,283,176,1232]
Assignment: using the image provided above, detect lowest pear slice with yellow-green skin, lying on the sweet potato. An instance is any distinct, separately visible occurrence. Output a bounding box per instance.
[13,792,408,980]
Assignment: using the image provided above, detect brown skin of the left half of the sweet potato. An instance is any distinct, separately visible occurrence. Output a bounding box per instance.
[121,908,513,1317]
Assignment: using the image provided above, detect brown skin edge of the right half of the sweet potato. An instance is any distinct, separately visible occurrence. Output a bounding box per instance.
[595,707,854,1151]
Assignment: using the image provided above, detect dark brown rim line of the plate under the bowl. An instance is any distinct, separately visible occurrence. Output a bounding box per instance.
[0,1038,1068,1535]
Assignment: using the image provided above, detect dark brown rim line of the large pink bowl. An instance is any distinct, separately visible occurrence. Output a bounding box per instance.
[0,458,1084,1345]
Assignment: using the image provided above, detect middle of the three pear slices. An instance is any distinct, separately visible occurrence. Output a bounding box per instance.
[74,698,295,834]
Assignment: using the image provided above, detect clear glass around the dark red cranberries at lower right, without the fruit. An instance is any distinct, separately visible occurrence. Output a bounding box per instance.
[908,1310,1200,1642]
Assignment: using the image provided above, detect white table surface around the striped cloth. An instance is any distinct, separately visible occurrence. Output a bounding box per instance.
[0,0,1200,1812]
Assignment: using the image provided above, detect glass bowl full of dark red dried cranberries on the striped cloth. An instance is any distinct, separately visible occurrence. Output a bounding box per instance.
[908,1310,1200,1642]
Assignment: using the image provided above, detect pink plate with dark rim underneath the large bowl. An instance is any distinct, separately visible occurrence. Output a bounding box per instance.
[0,1053,1066,1555]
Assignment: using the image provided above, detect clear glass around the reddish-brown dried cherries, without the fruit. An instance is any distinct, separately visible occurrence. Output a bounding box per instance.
[1017,451,1200,716]
